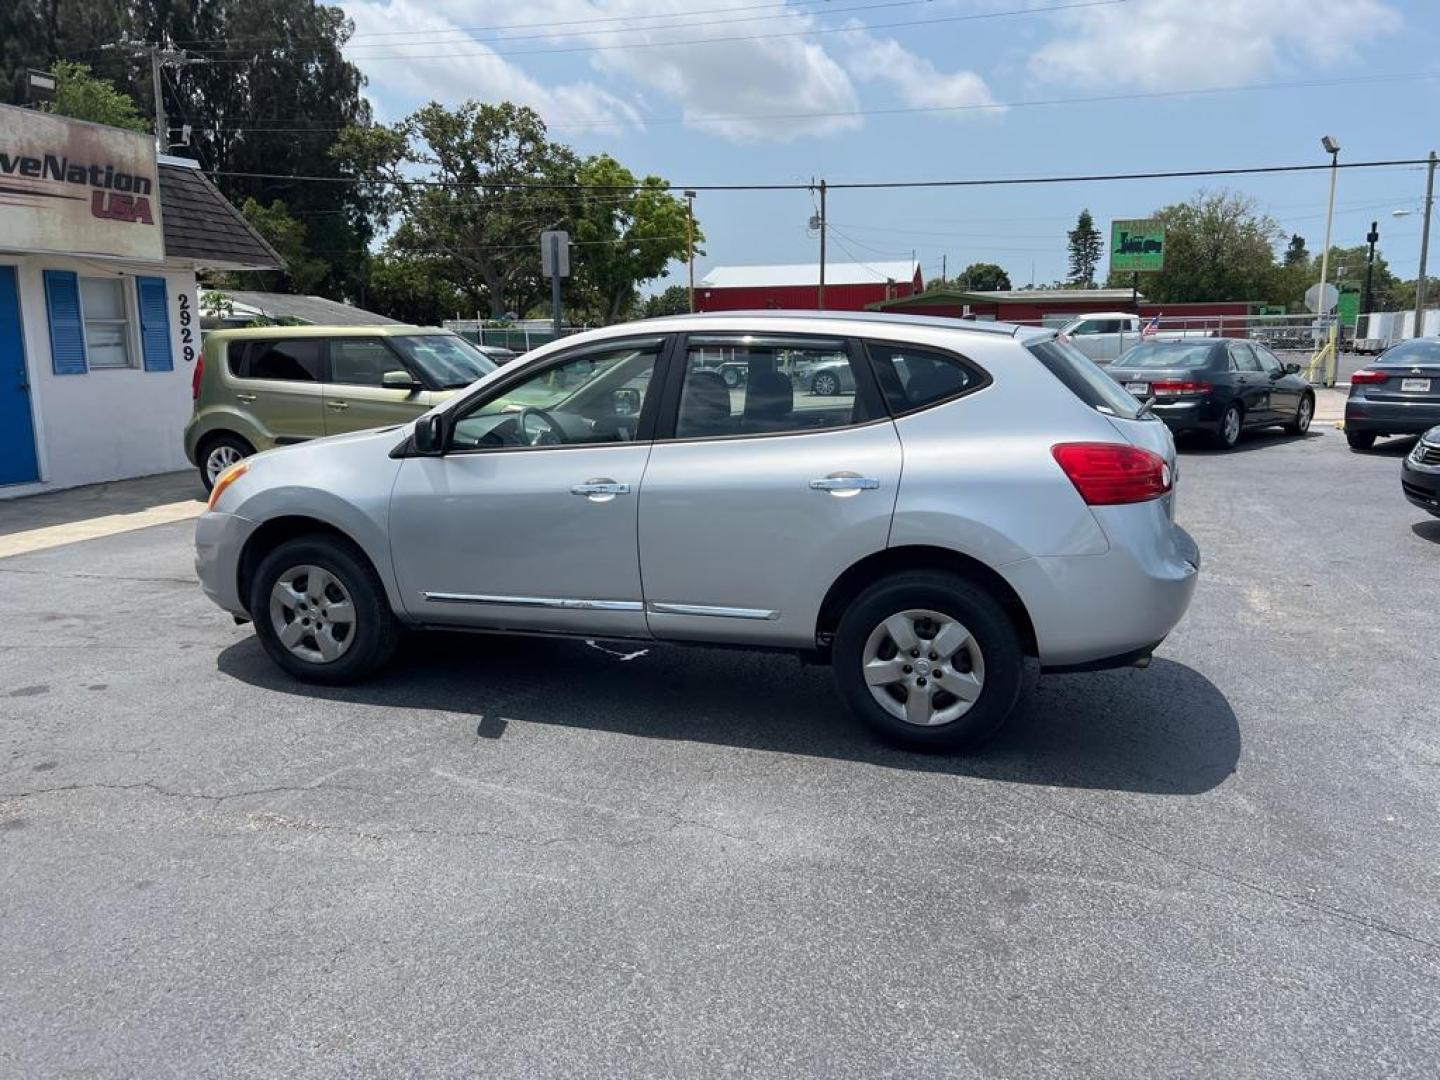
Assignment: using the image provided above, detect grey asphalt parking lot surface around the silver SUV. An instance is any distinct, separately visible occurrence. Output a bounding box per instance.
[0,425,1440,1077]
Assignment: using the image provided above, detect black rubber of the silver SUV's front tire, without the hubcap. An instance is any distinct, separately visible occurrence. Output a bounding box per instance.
[249,533,400,685]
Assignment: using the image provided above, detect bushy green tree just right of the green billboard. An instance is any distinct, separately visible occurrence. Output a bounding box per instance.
[1106,190,1284,304]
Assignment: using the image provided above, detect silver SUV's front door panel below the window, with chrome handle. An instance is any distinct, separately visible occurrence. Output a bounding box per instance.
[390,442,651,636]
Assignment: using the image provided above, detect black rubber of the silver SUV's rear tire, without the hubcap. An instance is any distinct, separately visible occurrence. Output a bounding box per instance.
[831,572,1025,752]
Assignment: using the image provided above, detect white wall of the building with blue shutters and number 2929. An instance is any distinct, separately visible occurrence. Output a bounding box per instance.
[0,253,200,498]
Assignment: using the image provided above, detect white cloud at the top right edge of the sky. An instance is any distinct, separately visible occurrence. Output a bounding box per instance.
[1030,0,1401,89]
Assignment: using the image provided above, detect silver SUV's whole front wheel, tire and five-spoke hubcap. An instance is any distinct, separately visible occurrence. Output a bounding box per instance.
[249,536,399,683]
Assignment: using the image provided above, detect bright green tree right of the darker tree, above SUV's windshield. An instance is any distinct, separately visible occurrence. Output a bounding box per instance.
[570,154,704,323]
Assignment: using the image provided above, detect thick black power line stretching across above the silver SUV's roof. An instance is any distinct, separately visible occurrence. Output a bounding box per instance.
[210,157,1428,192]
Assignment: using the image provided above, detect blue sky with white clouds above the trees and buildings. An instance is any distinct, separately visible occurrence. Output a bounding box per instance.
[331,0,1440,289]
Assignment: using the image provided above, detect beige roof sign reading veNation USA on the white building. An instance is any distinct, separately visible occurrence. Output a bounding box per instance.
[0,105,166,262]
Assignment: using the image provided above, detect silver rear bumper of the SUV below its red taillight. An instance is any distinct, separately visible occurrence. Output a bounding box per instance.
[999,512,1200,670]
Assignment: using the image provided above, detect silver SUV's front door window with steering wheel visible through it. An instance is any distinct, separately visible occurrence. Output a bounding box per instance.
[451,343,660,451]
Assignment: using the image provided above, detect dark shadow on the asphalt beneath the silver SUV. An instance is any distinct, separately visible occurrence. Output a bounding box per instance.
[219,634,1240,795]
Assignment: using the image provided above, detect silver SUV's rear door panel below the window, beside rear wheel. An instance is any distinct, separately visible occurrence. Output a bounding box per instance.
[639,420,900,647]
